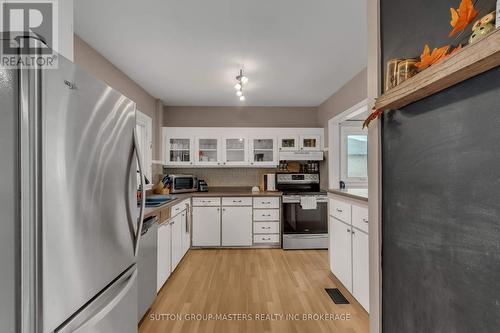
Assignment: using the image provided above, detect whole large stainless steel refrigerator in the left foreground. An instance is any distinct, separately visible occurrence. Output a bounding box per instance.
[0,49,144,333]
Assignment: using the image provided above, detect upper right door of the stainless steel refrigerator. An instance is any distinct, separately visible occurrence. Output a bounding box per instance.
[41,57,137,332]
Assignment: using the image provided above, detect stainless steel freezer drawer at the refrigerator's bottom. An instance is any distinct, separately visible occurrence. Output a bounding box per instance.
[54,265,137,333]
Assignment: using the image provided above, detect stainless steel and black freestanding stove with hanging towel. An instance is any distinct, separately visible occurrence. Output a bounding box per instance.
[276,173,328,249]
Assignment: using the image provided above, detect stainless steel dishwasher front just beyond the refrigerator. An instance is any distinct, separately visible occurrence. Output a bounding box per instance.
[137,216,158,322]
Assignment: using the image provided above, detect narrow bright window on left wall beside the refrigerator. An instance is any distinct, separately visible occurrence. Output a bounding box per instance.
[136,111,153,184]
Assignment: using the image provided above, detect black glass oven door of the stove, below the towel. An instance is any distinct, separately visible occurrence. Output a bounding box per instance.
[282,202,328,234]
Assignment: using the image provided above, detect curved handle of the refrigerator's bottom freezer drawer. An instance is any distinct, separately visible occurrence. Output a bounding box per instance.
[55,266,137,333]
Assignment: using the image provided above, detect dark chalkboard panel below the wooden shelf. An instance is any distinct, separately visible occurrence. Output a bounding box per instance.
[382,68,500,333]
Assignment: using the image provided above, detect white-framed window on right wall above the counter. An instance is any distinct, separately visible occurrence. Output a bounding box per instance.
[340,121,368,187]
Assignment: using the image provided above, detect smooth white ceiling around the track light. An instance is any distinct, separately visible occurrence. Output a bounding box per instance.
[74,0,367,107]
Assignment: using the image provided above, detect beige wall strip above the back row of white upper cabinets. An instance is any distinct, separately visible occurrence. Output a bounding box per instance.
[163,106,318,127]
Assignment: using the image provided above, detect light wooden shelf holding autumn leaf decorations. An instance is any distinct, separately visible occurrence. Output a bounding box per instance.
[375,29,500,111]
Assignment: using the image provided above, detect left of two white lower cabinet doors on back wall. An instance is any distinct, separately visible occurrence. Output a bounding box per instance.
[193,206,221,246]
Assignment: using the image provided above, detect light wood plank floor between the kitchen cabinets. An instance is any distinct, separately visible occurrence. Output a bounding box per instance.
[139,249,369,333]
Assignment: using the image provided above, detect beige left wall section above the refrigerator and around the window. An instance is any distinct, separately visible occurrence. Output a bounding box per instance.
[74,35,162,160]
